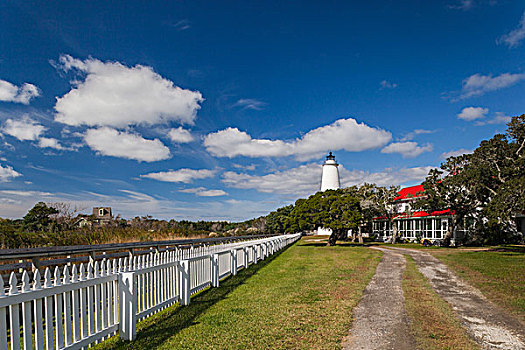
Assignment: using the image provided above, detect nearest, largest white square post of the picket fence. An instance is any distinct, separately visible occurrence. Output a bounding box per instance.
[118,272,137,340]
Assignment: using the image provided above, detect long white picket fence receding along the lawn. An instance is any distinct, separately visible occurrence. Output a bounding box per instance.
[0,234,300,350]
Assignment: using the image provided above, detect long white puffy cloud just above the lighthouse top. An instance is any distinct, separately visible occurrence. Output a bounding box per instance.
[204,118,392,159]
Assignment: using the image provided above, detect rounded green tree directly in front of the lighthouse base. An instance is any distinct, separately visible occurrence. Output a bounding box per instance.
[290,189,361,245]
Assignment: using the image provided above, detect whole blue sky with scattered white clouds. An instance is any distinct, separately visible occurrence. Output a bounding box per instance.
[0,0,525,221]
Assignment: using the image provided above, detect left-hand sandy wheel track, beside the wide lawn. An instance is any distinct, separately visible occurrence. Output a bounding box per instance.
[342,248,415,350]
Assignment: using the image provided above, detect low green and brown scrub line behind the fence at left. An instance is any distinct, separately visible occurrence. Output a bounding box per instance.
[0,202,266,249]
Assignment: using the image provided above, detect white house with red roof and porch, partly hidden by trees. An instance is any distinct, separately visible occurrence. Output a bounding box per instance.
[372,185,464,244]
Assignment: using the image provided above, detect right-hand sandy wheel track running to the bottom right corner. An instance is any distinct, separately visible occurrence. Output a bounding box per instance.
[386,248,525,350]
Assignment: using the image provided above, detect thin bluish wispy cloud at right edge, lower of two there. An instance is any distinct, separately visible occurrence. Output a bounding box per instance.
[459,73,525,100]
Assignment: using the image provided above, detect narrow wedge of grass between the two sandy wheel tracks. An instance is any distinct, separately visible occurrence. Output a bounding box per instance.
[402,255,479,350]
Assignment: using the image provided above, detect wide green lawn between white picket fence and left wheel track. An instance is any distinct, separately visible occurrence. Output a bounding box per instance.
[97,239,381,349]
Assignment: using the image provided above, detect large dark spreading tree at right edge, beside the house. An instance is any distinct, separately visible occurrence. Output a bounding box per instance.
[414,115,525,245]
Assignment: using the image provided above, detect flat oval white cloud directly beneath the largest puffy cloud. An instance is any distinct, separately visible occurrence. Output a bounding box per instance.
[84,127,170,162]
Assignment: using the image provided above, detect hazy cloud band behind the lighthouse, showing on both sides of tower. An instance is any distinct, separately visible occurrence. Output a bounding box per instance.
[222,163,432,196]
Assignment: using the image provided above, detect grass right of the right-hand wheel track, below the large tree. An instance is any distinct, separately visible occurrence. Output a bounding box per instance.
[432,246,525,323]
